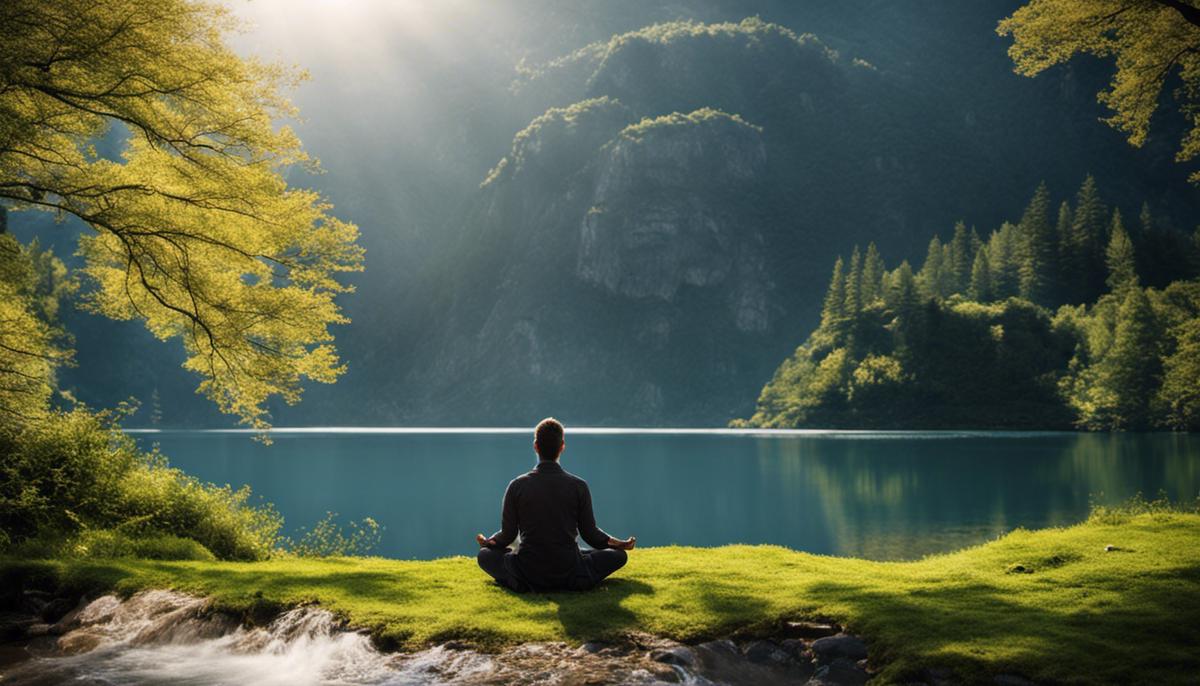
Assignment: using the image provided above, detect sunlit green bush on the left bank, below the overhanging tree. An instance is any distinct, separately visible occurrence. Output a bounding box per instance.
[0,409,283,560]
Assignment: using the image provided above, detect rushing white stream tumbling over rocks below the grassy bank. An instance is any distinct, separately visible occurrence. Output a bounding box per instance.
[0,590,704,686]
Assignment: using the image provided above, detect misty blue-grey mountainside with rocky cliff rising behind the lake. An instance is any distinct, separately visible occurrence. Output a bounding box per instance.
[18,0,1198,426]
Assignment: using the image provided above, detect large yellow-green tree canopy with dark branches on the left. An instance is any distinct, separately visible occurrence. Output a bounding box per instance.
[0,0,362,428]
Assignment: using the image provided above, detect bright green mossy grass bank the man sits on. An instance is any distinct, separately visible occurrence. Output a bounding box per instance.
[2,513,1200,684]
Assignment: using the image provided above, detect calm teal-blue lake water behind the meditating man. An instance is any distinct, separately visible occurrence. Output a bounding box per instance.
[138,429,1200,559]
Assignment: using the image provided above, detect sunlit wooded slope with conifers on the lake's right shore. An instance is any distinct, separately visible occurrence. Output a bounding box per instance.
[733,176,1200,431]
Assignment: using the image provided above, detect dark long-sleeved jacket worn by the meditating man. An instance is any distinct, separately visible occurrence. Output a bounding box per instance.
[492,461,608,588]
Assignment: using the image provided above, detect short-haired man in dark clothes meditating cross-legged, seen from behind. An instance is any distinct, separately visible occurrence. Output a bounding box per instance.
[475,417,637,592]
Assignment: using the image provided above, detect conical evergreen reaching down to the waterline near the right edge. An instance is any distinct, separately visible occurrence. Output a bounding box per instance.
[1096,288,1162,429]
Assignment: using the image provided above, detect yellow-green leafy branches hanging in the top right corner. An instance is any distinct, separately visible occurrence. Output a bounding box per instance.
[997,0,1200,183]
